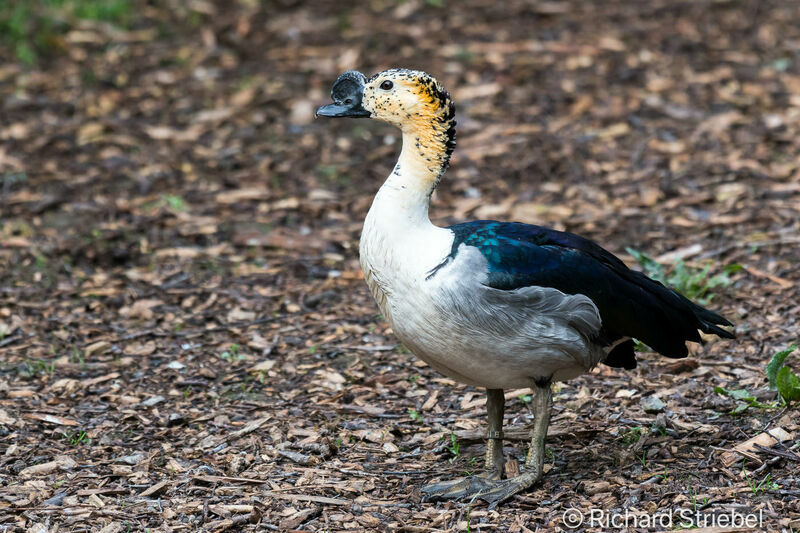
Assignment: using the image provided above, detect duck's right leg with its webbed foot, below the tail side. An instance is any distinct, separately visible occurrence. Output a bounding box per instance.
[478,382,553,509]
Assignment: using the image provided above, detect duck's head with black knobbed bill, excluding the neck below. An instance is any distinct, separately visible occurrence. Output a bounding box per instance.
[317,69,455,131]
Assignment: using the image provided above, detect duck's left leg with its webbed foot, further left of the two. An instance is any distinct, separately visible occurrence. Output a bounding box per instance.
[422,389,505,500]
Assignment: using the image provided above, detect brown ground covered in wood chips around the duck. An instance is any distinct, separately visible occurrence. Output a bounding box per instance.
[0,0,800,533]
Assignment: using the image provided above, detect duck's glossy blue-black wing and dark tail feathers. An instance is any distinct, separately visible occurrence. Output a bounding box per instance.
[449,220,733,368]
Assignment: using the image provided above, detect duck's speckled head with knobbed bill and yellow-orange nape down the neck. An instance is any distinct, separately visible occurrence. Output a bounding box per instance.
[317,68,456,179]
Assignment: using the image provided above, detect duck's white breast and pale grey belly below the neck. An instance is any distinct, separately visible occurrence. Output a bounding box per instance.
[361,212,603,389]
